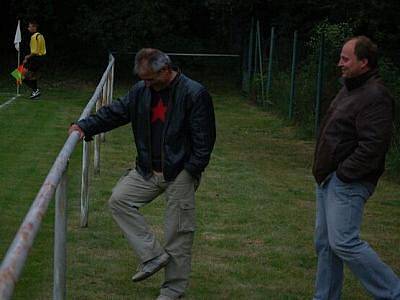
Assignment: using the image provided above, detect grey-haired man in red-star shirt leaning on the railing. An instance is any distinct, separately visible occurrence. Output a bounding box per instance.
[70,48,215,300]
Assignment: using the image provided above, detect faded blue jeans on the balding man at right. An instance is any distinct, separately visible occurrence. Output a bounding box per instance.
[314,173,400,300]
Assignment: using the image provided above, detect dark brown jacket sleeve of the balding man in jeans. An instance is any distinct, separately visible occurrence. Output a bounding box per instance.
[336,98,393,182]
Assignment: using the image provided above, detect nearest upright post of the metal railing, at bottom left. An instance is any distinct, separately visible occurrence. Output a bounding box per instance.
[53,165,68,300]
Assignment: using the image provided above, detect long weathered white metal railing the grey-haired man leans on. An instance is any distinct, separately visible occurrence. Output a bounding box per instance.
[0,54,115,300]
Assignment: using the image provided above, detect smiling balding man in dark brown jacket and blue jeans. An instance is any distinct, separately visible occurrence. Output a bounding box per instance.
[313,36,400,300]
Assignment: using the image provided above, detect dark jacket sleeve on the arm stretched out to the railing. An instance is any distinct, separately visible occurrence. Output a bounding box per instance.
[77,91,134,141]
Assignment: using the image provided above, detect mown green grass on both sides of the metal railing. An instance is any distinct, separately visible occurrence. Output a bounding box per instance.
[0,77,400,299]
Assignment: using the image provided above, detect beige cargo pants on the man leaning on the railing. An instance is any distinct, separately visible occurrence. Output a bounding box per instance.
[109,170,198,297]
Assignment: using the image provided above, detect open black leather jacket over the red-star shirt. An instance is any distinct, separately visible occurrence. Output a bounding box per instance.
[77,73,215,181]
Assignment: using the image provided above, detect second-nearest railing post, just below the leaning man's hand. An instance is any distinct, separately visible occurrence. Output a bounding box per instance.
[81,142,90,227]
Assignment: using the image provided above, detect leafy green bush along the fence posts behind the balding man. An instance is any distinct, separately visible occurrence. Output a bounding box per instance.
[251,21,400,175]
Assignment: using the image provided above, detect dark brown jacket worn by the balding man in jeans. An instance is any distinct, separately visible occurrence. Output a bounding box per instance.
[313,71,394,185]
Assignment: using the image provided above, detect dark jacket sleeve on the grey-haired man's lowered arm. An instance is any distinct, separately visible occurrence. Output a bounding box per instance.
[185,90,216,177]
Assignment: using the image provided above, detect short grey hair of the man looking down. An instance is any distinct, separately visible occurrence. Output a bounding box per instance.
[134,48,172,74]
